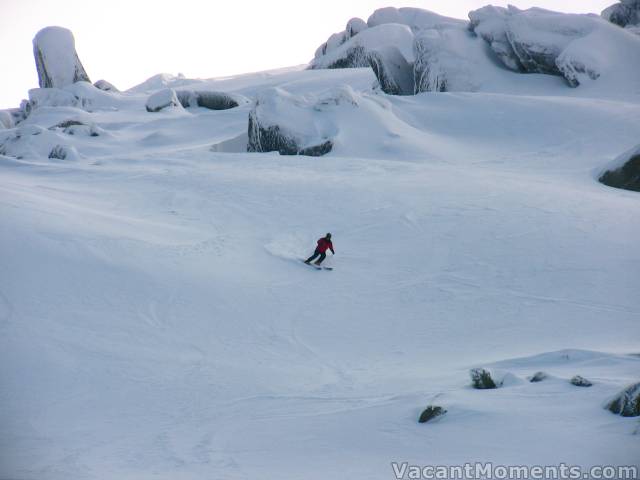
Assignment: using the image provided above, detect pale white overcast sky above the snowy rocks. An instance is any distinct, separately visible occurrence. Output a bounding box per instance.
[0,0,615,108]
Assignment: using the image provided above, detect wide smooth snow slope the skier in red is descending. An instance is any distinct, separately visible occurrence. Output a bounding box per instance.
[0,47,640,480]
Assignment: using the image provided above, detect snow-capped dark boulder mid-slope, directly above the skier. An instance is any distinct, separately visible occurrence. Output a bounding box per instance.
[247,88,333,157]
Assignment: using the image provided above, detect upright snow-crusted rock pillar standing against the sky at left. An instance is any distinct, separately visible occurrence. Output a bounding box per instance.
[33,27,91,88]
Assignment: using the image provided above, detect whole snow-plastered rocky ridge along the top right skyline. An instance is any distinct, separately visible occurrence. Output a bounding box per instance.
[309,6,640,95]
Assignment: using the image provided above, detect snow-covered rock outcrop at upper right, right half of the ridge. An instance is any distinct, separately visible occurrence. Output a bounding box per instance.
[469,6,640,87]
